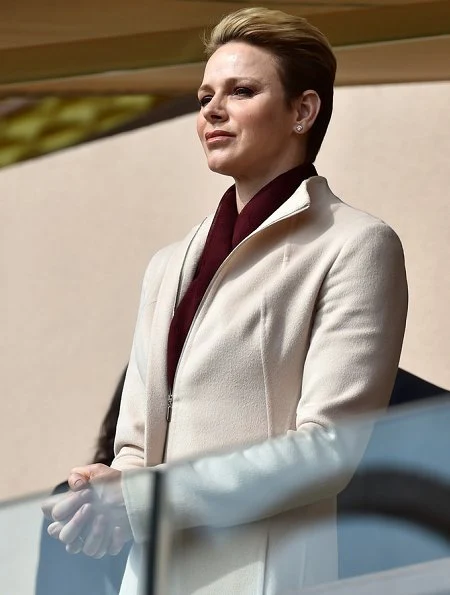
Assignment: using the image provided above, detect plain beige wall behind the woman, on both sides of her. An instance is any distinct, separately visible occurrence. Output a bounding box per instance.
[0,84,450,499]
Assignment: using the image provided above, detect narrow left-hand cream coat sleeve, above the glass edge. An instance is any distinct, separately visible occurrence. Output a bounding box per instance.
[111,246,173,471]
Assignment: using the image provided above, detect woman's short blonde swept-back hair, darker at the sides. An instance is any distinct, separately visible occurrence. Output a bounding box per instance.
[205,8,336,162]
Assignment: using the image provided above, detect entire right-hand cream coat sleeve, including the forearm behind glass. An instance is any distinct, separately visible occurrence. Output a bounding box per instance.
[119,221,407,540]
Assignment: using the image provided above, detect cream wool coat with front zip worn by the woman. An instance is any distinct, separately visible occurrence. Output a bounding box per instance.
[113,176,407,595]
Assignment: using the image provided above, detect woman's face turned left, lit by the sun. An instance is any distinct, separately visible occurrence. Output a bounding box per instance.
[197,42,301,181]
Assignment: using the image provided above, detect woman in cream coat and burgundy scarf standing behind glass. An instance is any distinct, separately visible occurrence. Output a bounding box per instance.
[44,8,407,595]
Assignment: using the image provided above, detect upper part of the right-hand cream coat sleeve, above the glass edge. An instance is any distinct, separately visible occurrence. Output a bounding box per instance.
[296,220,408,428]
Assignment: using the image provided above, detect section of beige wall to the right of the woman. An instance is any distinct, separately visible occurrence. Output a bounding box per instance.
[318,83,450,389]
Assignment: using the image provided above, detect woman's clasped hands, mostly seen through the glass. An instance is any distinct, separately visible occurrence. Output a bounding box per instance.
[42,463,132,558]
